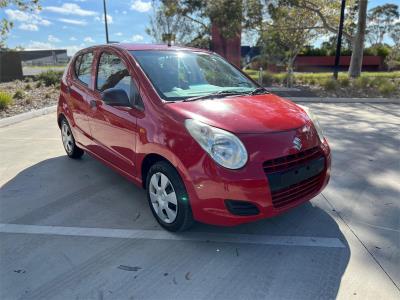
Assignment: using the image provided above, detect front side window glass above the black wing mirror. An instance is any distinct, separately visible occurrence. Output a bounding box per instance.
[96,53,143,107]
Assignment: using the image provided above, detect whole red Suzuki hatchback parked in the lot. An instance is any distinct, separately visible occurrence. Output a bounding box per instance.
[57,44,331,231]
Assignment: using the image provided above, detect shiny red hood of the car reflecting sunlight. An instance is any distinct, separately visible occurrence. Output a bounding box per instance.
[168,94,310,133]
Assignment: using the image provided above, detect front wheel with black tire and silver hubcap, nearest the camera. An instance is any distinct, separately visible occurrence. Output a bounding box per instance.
[146,161,194,232]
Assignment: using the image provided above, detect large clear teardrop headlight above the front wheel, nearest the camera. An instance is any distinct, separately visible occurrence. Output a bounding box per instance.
[185,119,247,169]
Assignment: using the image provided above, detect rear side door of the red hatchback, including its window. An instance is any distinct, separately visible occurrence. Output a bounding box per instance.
[67,52,93,146]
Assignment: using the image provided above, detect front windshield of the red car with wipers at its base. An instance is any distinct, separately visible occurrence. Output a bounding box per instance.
[131,50,257,101]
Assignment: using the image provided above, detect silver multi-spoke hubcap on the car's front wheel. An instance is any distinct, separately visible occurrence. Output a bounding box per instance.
[149,172,178,223]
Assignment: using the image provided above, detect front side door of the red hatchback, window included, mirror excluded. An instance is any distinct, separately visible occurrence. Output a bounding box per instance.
[89,52,143,176]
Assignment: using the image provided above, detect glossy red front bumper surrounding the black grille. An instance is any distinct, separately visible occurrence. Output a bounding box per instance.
[184,132,331,226]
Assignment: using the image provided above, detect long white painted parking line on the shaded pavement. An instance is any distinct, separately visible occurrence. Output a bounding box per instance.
[0,224,345,248]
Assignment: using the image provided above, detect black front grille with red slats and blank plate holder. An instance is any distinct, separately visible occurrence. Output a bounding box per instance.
[263,147,325,208]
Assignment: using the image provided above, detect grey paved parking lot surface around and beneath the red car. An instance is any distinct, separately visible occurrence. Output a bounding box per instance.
[0,104,400,299]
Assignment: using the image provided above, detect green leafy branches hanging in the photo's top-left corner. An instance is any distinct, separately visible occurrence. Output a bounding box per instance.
[0,0,40,47]
